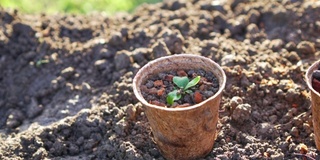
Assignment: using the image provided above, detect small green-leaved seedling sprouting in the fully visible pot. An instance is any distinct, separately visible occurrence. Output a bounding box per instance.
[167,76,200,105]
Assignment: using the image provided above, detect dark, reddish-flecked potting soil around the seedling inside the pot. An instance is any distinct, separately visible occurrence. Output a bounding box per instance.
[141,69,219,108]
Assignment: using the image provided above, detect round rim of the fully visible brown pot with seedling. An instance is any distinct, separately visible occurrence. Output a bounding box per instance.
[132,53,227,111]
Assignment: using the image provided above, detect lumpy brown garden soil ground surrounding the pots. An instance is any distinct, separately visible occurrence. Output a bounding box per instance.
[0,0,320,159]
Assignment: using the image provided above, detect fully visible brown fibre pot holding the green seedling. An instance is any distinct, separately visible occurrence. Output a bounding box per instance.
[133,54,226,160]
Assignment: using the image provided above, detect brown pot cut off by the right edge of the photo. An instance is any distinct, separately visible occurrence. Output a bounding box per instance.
[305,61,320,150]
